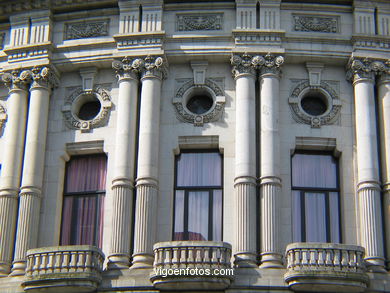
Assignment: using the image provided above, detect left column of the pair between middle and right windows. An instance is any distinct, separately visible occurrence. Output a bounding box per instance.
[231,54,257,267]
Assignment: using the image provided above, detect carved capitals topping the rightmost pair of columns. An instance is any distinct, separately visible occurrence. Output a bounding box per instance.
[347,58,390,83]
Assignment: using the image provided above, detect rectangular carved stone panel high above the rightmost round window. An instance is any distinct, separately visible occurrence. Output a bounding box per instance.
[293,15,339,33]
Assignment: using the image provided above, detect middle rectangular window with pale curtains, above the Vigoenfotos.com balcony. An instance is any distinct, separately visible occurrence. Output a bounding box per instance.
[173,152,222,241]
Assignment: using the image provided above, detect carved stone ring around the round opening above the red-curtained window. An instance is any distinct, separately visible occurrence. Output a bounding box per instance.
[62,87,112,132]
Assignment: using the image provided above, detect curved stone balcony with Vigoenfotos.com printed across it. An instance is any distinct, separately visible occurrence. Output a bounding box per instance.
[150,241,233,290]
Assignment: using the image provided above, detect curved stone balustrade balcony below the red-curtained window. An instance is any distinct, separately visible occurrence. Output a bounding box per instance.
[23,245,104,293]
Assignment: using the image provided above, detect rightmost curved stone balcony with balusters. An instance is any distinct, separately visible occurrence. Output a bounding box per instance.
[284,243,368,292]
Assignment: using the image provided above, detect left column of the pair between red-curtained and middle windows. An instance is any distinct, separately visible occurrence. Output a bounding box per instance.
[108,58,141,269]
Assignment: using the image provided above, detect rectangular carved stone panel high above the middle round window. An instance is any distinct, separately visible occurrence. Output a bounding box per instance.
[176,13,223,31]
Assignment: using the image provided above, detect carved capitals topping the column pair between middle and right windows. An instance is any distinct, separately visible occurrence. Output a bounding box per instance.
[230,53,284,78]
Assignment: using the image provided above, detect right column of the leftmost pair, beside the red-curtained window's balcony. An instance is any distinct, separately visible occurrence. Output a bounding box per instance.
[11,67,56,275]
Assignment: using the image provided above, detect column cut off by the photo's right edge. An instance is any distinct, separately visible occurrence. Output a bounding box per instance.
[378,68,390,268]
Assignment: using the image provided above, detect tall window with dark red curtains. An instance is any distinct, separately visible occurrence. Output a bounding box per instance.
[61,155,107,247]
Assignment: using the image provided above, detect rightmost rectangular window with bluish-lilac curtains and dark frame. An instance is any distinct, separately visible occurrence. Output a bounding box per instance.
[291,153,340,243]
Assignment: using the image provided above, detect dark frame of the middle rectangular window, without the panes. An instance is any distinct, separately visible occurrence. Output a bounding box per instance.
[171,148,224,241]
